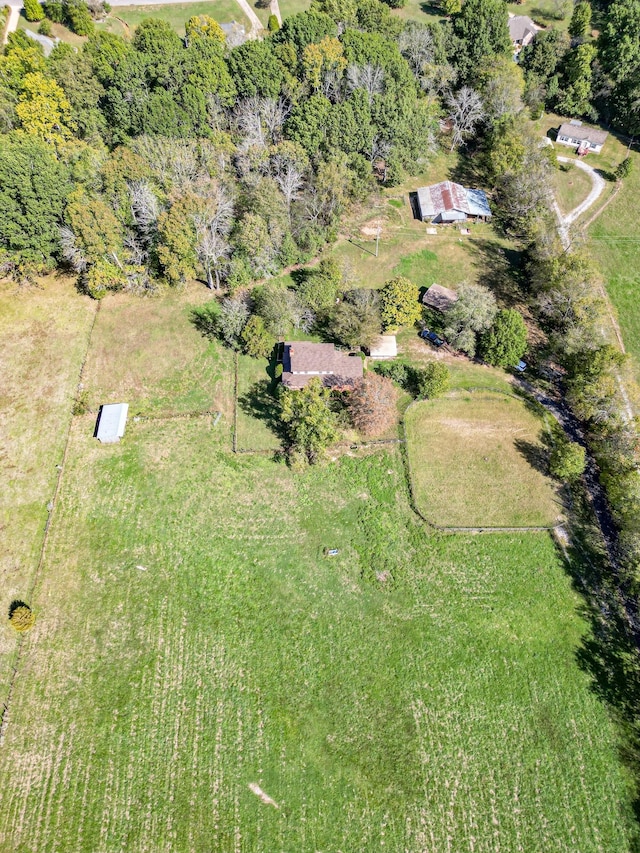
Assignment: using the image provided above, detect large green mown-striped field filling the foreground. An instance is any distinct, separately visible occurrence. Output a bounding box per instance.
[0,418,629,853]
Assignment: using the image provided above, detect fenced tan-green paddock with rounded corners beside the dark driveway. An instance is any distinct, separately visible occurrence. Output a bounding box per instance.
[405,391,562,527]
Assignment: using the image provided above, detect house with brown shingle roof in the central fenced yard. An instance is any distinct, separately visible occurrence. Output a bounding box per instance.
[282,341,363,391]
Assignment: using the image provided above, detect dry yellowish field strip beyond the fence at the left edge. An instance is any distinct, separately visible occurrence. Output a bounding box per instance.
[0,277,96,701]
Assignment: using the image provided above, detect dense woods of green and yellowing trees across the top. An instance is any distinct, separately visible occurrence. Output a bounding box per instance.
[0,0,640,290]
